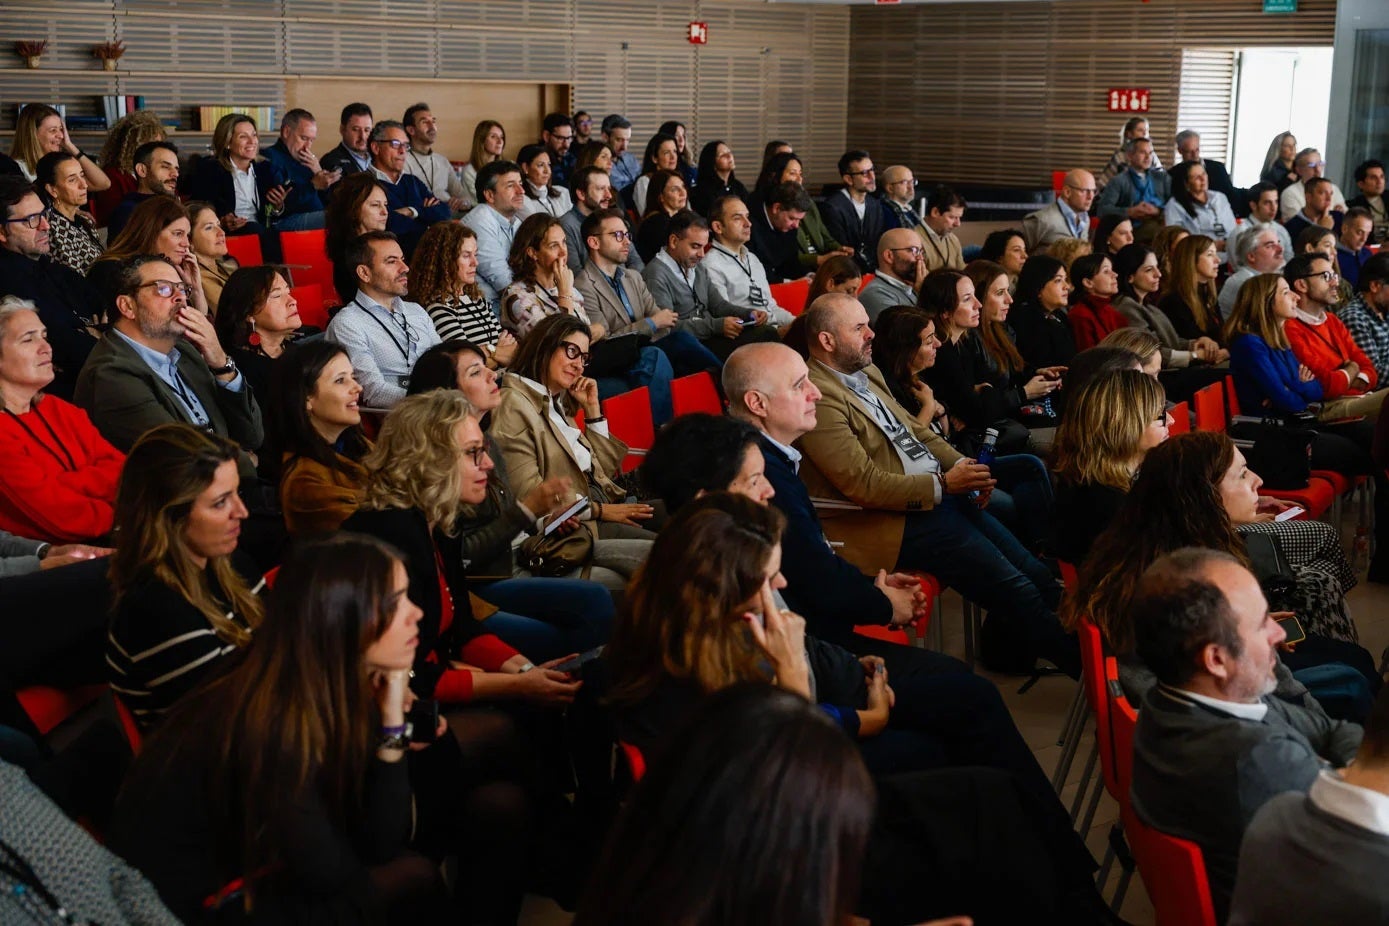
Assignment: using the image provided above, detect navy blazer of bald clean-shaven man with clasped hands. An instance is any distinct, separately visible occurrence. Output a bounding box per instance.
[757,437,892,648]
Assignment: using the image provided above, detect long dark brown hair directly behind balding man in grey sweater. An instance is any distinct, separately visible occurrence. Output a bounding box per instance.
[1061,430,1249,655]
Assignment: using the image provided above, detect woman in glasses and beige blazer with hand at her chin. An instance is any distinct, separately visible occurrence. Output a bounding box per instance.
[488,315,654,579]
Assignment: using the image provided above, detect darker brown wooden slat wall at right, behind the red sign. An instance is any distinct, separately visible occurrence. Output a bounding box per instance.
[846,0,1336,187]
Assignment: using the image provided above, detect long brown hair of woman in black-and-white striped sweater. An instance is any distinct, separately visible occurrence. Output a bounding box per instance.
[110,423,261,646]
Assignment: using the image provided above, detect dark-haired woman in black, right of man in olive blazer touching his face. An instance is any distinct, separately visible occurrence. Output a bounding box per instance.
[217,264,318,396]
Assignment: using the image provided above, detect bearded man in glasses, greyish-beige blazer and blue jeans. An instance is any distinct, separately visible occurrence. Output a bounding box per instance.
[574,210,724,376]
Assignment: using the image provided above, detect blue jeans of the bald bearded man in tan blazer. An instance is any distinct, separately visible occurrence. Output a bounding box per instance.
[897,496,1081,677]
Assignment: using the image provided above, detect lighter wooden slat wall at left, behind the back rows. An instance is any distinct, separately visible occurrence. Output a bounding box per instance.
[0,0,850,183]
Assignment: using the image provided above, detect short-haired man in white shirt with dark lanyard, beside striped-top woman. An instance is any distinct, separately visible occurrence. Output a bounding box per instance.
[328,232,439,408]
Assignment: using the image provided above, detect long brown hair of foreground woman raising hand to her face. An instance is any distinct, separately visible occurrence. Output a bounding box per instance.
[607,491,786,704]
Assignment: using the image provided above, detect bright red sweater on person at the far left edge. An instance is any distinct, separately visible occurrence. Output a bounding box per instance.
[0,396,125,543]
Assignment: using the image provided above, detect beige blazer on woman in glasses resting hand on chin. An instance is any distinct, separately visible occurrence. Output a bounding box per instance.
[488,376,626,526]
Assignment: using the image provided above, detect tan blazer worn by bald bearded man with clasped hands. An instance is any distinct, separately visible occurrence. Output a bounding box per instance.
[797,360,961,573]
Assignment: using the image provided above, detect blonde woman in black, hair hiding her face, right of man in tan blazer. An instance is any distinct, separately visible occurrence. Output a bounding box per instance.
[1051,369,1172,566]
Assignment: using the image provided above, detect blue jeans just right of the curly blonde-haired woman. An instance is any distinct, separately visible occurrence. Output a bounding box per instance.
[478,579,615,664]
